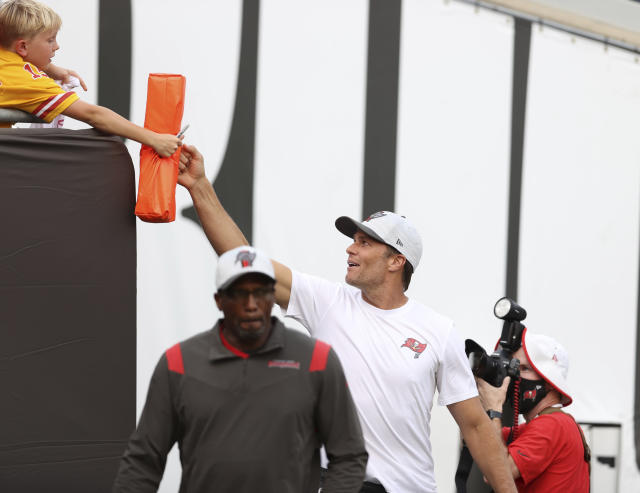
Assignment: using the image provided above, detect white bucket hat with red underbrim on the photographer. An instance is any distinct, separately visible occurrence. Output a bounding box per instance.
[522,329,573,406]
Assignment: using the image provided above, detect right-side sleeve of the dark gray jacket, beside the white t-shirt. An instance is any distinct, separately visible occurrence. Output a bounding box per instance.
[316,349,368,493]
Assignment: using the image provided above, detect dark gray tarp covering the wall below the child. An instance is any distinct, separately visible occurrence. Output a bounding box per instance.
[0,129,136,493]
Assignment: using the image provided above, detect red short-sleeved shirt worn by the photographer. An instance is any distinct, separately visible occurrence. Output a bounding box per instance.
[506,412,589,493]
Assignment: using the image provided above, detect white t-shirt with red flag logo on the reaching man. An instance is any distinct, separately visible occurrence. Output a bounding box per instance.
[286,272,478,493]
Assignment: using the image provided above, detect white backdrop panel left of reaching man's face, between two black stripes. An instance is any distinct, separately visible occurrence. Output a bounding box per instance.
[253,0,368,279]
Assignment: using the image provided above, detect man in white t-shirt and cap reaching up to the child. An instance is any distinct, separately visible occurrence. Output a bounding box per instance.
[178,145,517,493]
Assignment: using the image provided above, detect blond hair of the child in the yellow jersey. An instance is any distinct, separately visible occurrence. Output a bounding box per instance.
[0,0,62,48]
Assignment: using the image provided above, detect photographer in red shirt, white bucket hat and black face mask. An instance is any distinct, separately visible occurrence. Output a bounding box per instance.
[477,329,590,493]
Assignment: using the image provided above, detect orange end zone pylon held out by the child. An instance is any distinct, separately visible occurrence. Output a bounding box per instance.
[136,74,186,223]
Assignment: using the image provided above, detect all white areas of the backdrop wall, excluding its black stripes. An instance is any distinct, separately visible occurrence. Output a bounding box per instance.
[31,0,640,492]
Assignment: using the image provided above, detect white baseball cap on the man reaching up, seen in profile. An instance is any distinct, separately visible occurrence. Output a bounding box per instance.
[336,211,422,271]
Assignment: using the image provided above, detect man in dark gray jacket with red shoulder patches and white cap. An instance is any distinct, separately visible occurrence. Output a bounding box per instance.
[113,246,367,493]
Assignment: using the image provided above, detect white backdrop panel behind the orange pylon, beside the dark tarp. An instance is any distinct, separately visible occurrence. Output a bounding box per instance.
[129,0,242,493]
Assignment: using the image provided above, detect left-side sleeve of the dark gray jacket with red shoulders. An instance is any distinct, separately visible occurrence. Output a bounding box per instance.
[113,355,178,493]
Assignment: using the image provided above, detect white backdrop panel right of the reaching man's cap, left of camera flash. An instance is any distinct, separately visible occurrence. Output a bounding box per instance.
[396,0,513,493]
